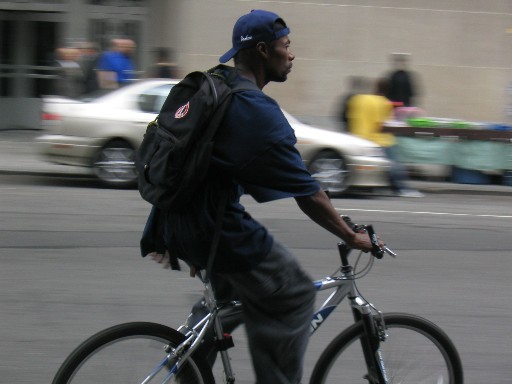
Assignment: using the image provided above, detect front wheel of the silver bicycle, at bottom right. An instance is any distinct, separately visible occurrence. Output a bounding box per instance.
[310,313,464,384]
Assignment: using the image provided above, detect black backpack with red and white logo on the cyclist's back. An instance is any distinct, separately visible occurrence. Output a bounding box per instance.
[137,66,259,211]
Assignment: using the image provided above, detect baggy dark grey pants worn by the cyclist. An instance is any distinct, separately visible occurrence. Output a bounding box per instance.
[188,242,315,384]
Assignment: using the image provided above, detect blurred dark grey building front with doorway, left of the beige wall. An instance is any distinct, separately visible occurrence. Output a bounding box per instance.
[0,0,148,129]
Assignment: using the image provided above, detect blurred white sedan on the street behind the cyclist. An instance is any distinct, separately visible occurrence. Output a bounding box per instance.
[36,80,389,194]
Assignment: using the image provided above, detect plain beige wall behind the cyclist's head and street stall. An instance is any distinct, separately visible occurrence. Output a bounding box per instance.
[162,0,512,128]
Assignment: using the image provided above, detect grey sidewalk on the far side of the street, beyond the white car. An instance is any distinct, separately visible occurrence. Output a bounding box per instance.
[0,130,512,197]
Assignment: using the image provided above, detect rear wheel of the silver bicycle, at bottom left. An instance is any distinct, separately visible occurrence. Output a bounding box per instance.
[52,322,215,384]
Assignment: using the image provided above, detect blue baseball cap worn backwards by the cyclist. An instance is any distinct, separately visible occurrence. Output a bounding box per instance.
[219,10,290,63]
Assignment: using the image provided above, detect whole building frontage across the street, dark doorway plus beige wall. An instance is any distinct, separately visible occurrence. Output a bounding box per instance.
[0,0,512,129]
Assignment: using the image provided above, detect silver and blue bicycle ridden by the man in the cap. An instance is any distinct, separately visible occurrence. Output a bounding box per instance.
[53,216,463,384]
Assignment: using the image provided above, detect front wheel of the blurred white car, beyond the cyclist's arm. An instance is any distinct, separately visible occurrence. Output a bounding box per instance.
[308,151,349,196]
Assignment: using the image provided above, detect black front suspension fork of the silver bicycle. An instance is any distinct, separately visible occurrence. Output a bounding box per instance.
[351,297,389,384]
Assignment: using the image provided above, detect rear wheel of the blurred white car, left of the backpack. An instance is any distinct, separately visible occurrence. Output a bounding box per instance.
[92,139,137,187]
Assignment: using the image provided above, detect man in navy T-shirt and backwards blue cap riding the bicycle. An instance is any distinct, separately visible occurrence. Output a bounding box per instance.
[142,10,378,384]
